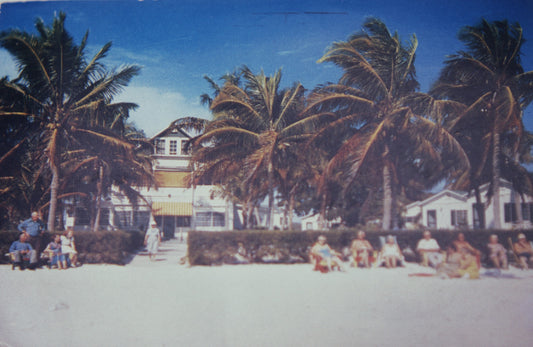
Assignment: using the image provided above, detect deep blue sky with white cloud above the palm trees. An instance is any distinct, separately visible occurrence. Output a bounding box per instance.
[0,0,533,136]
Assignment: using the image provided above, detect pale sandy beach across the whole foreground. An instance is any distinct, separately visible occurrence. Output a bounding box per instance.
[0,247,533,347]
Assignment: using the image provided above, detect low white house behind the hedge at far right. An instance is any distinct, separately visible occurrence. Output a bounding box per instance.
[403,180,533,229]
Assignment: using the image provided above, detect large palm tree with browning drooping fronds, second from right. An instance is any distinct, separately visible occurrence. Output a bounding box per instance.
[305,18,468,230]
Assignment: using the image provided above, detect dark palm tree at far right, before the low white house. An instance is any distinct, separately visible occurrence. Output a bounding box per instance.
[432,20,533,228]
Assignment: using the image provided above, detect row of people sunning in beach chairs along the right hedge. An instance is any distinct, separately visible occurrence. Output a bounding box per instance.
[310,230,533,278]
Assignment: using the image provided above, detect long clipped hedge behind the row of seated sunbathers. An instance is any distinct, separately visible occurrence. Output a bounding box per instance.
[188,230,533,265]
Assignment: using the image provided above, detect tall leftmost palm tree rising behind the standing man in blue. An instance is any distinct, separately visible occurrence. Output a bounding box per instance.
[0,13,139,231]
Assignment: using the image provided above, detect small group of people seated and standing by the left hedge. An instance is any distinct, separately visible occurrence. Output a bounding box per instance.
[9,212,78,270]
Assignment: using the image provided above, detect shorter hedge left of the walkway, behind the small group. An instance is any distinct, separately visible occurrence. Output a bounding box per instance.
[0,231,144,265]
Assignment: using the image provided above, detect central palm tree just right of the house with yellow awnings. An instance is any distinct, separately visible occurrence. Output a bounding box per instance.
[195,66,309,229]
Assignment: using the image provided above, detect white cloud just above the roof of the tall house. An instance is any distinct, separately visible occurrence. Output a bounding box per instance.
[115,86,210,137]
